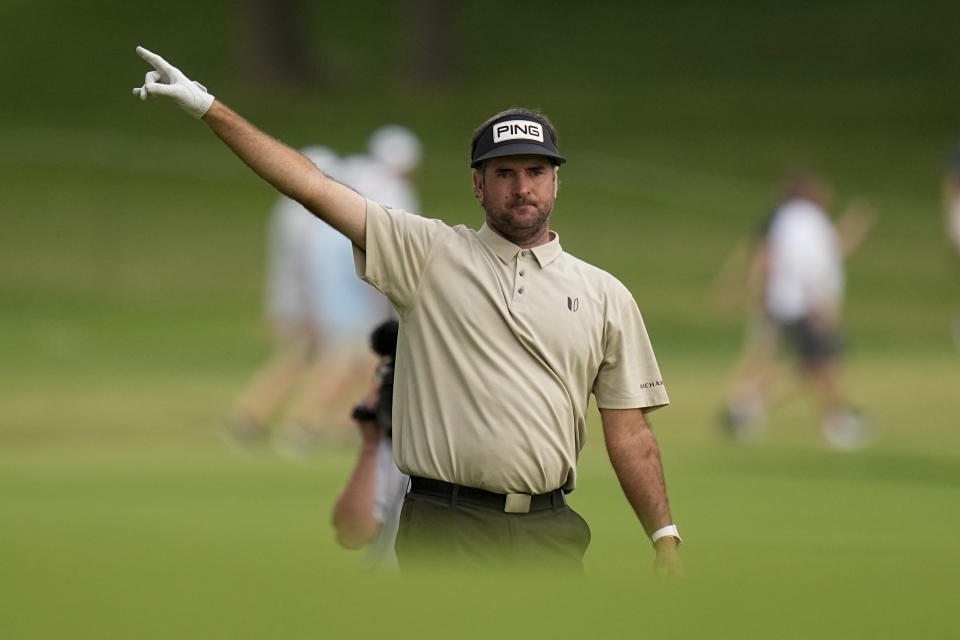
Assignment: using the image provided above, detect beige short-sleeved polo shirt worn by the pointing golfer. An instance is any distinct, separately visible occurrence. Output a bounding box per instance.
[354,201,669,494]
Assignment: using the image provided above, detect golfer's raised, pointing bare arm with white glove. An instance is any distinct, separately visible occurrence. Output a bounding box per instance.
[133,47,366,249]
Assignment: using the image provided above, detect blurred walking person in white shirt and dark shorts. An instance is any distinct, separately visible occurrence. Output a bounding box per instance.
[721,173,874,449]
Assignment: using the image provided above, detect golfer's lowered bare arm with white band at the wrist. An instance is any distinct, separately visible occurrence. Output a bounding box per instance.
[600,409,681,574]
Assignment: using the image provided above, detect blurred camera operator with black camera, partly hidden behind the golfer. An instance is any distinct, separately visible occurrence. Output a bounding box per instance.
[333,320,409,568]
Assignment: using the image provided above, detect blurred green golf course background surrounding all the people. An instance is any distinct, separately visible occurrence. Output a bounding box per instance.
[0,0,960,638]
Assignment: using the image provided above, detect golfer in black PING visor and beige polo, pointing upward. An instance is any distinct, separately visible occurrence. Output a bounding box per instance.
[133,47,680,573]
